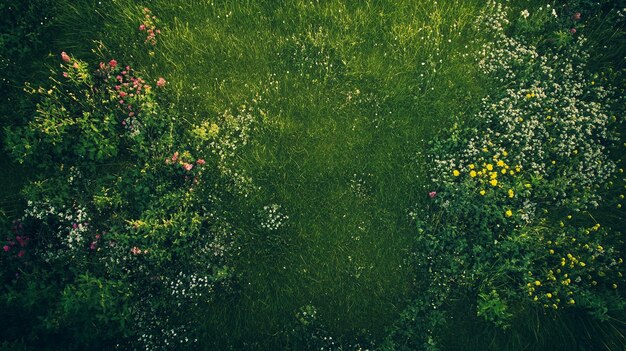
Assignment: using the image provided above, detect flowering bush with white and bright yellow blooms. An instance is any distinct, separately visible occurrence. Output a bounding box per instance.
[390,3,625,348]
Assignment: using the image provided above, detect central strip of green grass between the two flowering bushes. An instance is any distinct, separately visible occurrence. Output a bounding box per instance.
[2,0,620,349]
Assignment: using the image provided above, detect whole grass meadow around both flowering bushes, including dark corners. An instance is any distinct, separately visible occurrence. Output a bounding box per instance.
[0,0,626,350]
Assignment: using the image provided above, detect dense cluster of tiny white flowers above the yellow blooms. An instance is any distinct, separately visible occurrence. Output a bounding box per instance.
[435,2,617,209]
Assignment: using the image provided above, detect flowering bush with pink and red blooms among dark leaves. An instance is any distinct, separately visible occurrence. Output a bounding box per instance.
[0,48,249,349]
